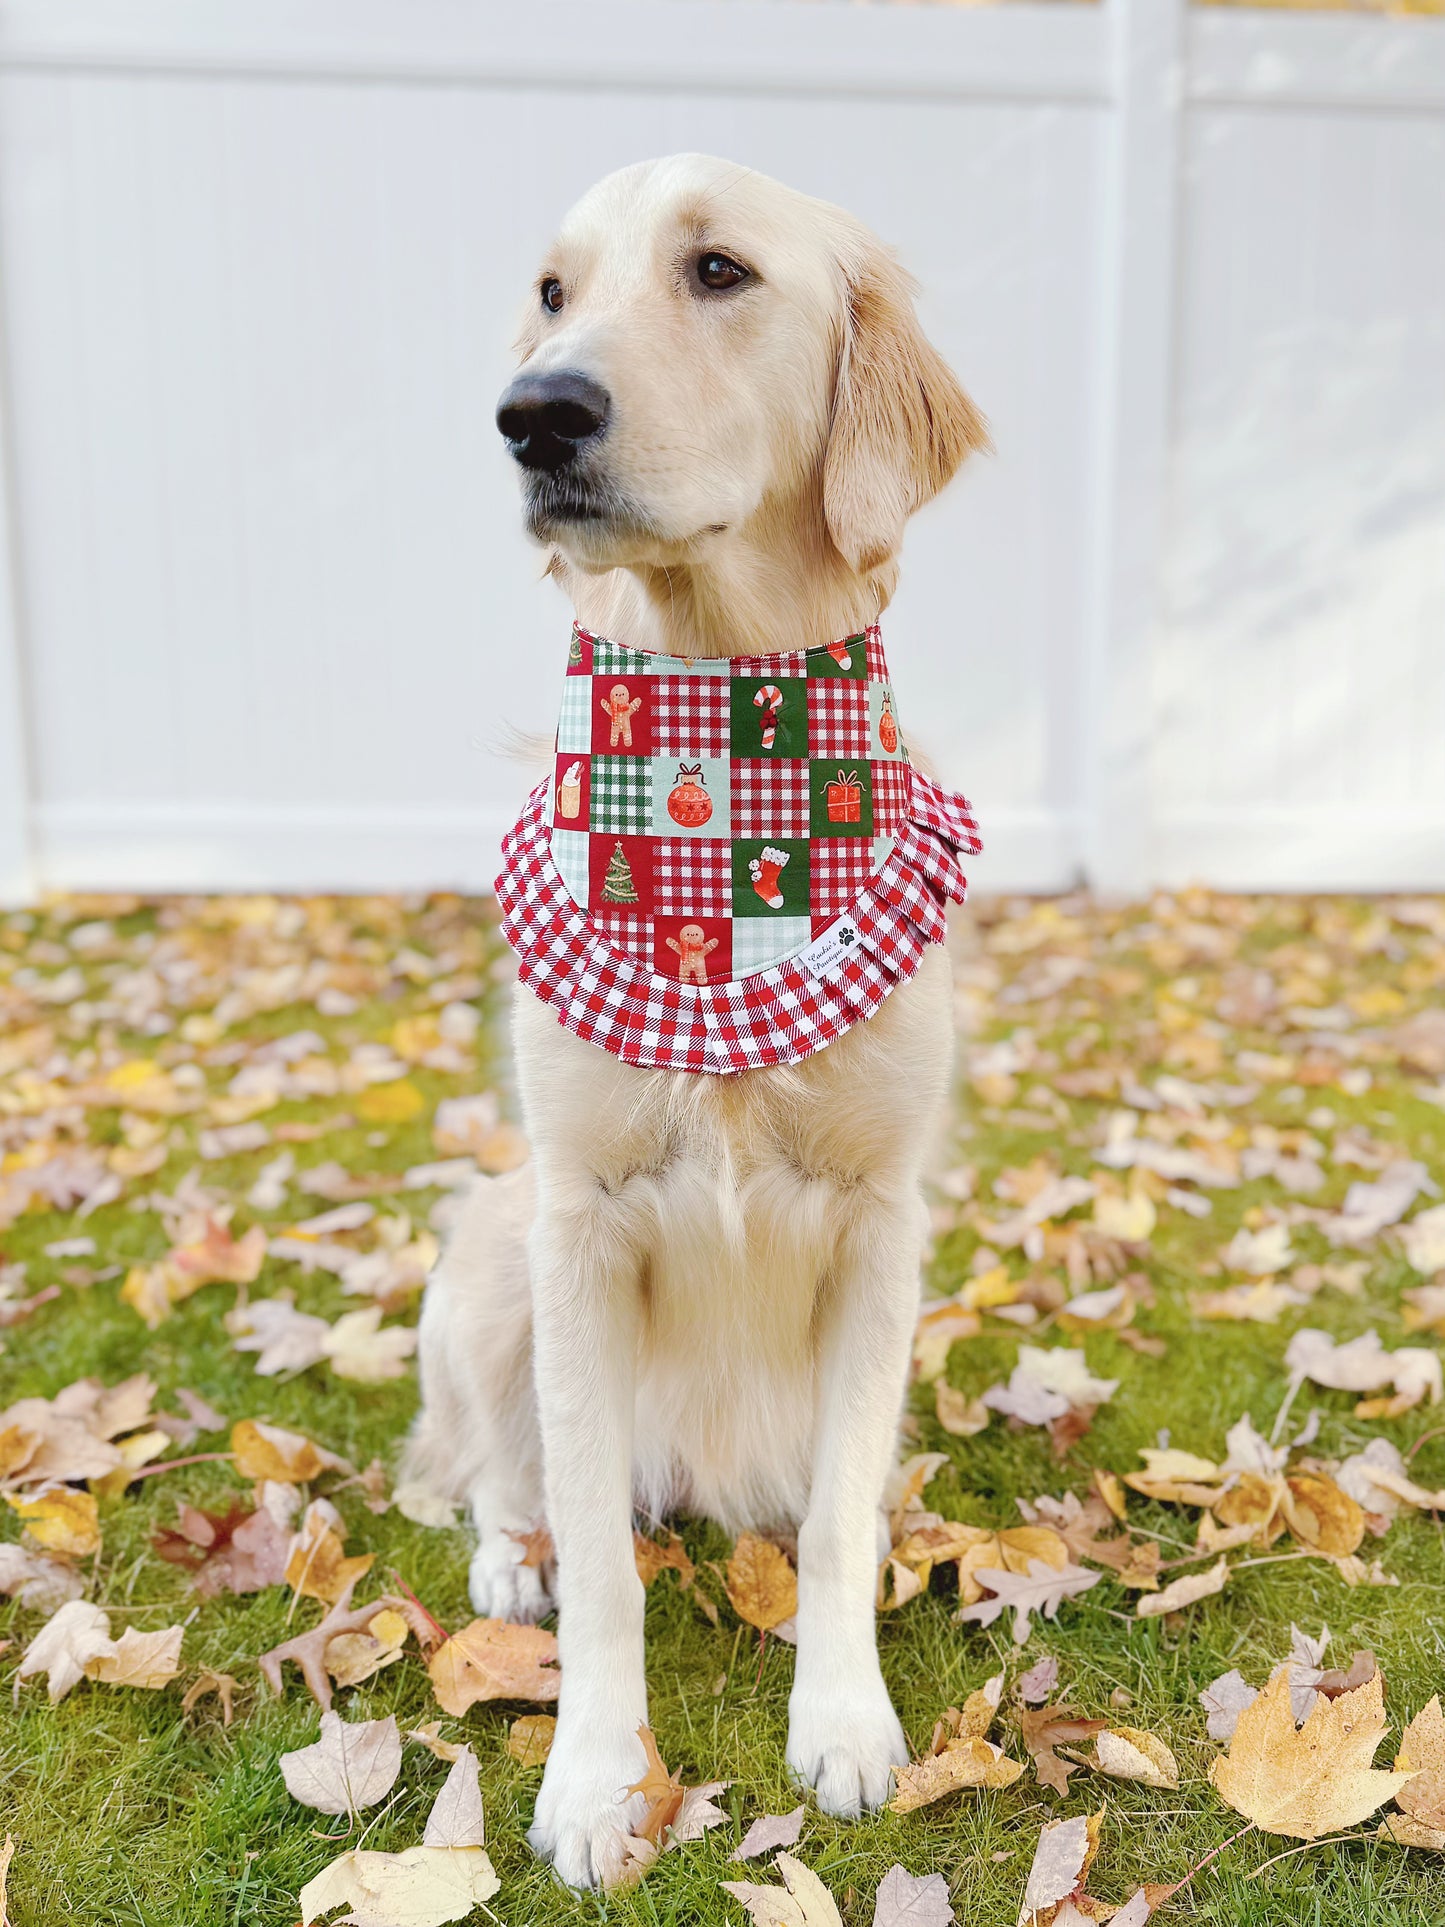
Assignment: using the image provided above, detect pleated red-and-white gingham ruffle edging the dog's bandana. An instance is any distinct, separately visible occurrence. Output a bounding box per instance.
[497,765,983,1073]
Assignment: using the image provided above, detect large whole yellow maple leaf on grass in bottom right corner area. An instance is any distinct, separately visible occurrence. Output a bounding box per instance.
[1210,1671,1410,1840]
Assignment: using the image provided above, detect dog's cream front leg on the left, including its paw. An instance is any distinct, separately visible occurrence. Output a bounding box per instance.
[528,1193,647,1887]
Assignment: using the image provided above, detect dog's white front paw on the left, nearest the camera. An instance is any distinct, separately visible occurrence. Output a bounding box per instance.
[526,1732,647,1888]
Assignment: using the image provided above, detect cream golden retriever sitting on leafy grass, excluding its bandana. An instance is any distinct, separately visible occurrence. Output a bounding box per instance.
[412,154,986,1887]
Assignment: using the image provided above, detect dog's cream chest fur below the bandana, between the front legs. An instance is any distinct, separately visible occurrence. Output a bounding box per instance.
[514,950,952,1530]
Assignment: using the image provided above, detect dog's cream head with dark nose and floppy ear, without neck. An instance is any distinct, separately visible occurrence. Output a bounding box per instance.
[497,154,986,574]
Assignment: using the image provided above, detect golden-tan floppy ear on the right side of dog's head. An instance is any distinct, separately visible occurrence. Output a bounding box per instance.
[823,243,988,572]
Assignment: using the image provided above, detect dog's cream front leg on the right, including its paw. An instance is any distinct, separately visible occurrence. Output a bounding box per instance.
[788,1193,923,1815]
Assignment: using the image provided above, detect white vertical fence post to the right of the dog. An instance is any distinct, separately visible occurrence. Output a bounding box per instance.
[1081,0,1187,894]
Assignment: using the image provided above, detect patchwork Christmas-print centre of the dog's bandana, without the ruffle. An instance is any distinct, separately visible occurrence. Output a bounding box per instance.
[547,628,909,989]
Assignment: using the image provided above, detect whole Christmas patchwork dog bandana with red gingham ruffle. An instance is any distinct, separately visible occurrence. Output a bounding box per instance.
[497,626,983,1071]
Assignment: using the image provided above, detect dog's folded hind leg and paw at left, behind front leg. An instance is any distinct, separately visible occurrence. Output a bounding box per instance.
[405,1166,551,1621]
